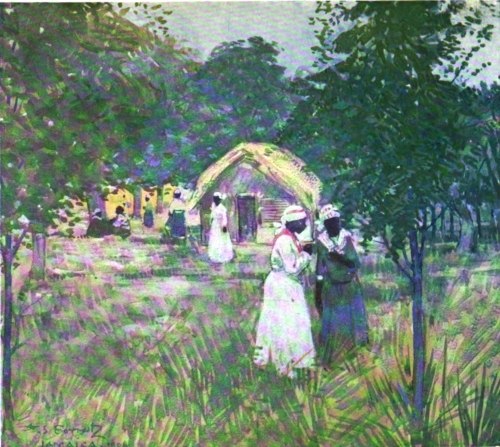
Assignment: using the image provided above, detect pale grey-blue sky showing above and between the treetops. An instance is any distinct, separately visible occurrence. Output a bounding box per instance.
[126,0,500,83]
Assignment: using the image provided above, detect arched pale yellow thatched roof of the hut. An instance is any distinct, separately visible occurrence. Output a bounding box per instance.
[188,143,321,209]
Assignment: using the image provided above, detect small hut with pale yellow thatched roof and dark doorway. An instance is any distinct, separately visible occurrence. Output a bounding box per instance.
[188,143,321,242]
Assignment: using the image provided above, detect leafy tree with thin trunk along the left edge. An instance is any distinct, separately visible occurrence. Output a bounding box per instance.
[0,4,154,438]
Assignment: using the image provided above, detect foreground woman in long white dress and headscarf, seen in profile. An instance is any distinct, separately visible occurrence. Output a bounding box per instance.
[254,205,316,377]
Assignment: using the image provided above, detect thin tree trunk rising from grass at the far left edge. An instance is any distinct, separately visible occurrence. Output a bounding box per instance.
[2,234,14,435]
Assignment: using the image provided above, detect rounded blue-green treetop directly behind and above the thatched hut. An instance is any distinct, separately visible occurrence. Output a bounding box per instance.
[197,37,294,149]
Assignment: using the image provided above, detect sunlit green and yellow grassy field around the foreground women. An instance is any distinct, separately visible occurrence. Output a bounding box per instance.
[7,226,500,447]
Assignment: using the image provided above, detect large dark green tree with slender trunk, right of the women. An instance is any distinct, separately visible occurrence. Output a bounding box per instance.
[281,2,491,445]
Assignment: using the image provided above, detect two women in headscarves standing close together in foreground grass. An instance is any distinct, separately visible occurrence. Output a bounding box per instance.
[254,204,368,377]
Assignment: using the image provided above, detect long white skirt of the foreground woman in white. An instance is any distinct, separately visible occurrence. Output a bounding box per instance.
[254,271,316,377]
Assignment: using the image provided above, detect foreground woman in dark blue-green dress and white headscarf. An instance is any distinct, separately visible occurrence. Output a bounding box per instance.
[316,205,368,365]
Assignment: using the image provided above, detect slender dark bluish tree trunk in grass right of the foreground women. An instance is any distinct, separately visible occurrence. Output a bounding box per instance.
[409,230,425,445]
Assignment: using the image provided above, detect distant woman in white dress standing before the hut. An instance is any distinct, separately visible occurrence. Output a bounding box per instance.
[208,192,234,263]
